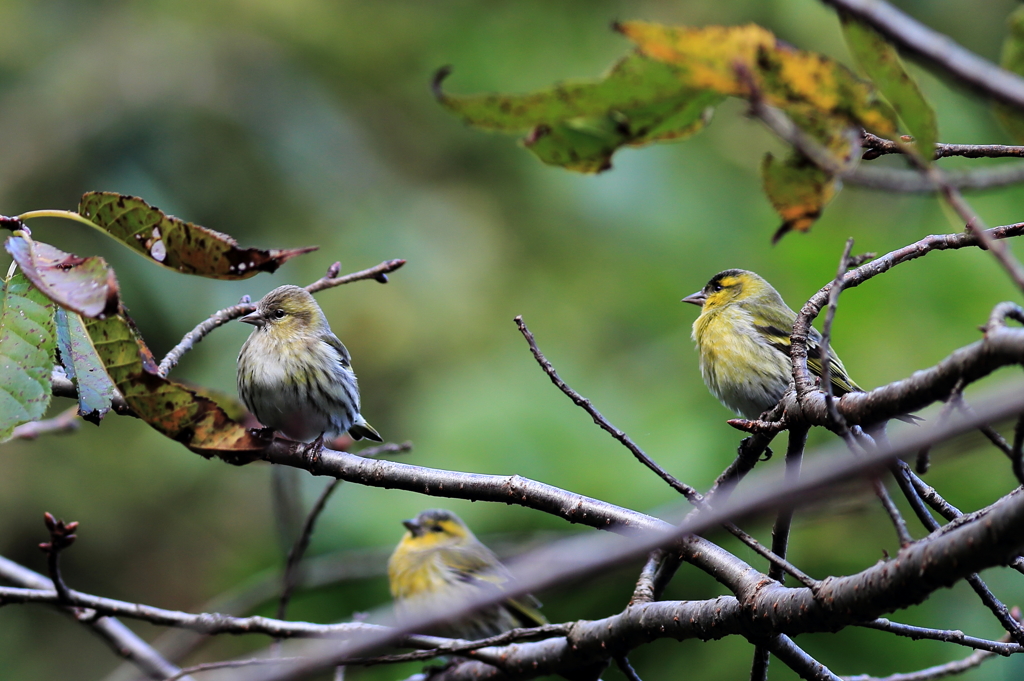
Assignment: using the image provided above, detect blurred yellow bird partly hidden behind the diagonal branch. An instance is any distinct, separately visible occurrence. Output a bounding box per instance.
[387,509,547,640]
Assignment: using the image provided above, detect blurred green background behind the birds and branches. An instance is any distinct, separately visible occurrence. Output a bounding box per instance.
[0,0,1024,681]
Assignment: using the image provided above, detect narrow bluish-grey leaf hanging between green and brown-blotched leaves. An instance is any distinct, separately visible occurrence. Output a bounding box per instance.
[56,308,118,425]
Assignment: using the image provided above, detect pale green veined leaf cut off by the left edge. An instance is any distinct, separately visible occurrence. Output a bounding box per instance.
[0,272,54,440]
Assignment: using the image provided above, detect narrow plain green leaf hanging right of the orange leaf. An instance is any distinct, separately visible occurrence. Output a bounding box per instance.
[841,14,939,164]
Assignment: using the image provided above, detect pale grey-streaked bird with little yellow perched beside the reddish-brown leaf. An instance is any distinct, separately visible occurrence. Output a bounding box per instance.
[238,286,381,450]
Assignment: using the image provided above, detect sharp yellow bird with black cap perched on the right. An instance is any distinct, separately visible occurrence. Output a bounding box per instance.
[682,269,860,419]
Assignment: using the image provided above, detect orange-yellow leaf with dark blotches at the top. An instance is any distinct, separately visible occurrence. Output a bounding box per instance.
[617,22,896,136]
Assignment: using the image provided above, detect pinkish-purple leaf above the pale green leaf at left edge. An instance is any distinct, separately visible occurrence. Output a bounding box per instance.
[4,237,119,317]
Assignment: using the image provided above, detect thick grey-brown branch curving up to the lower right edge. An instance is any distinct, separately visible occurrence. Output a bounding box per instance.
[425,485,1024,681]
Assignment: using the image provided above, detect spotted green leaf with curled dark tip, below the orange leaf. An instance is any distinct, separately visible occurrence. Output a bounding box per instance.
[434,54,723,172]
